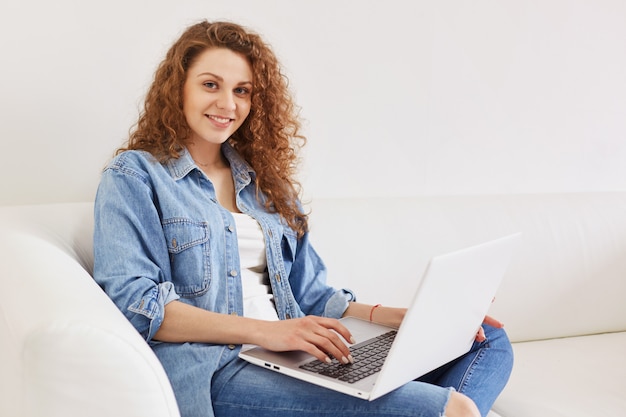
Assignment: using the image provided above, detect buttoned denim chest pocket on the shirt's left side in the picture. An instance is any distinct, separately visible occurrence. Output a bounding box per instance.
[163,218,211,298]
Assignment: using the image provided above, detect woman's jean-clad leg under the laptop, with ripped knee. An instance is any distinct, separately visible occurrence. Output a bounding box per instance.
[212,360,454,417]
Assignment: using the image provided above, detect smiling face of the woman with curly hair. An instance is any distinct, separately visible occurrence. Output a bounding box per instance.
[183,48,252,146]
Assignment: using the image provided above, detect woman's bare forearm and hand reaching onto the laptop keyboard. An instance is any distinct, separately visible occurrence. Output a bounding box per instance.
[154,301,352,363]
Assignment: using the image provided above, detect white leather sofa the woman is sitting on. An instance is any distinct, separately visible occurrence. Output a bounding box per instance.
[0,192,626,417]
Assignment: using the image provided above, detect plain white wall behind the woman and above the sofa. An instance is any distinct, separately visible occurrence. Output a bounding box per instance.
[0,0,626,204]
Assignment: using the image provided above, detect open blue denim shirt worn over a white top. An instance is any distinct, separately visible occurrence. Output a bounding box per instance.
[94,144,354,406]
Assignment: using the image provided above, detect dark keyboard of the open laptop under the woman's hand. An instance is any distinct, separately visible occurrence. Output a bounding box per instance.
[300,330,397,384]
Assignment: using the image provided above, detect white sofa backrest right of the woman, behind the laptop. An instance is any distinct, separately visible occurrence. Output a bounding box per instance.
[310,192,626,341]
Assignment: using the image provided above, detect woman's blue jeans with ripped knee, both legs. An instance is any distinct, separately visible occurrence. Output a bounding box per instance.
[207,326,513,417]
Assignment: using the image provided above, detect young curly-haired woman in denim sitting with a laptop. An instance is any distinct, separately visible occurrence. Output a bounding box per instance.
[94,22,512,417]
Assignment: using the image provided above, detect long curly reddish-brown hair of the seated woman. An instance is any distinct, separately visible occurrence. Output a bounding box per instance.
[117,21,308,237]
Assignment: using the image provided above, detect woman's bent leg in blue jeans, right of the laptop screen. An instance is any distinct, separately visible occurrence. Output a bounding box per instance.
[418,325,513,416]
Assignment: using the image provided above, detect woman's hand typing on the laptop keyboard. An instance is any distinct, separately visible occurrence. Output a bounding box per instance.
[251,316,355,364]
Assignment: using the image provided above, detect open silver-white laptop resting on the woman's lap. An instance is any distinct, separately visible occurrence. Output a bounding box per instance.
[239,233,521,401]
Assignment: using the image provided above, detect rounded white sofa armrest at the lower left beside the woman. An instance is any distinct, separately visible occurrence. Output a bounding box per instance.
[0,218,179,417]
